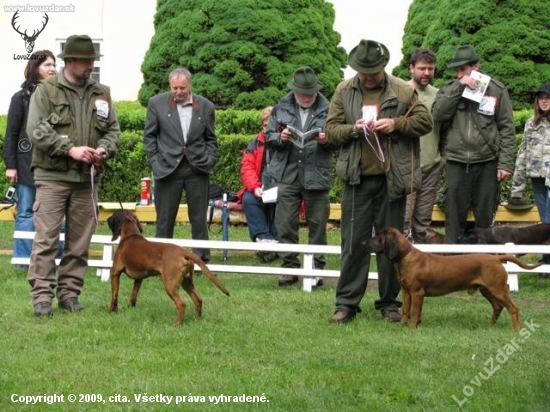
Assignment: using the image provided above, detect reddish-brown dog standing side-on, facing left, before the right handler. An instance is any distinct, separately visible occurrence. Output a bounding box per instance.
[367,228,540,330]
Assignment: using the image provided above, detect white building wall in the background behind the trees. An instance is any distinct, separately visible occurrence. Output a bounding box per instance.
[0,0,412,113]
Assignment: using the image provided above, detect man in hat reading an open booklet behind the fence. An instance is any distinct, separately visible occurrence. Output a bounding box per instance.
[265,66,332,286]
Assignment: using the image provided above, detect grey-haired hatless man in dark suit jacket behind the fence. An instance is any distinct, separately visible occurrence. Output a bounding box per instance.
[144,68,218,262]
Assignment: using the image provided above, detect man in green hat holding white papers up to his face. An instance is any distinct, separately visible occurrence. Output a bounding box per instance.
[432,45,516,243]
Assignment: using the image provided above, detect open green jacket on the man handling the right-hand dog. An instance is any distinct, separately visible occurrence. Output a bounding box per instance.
[325,74,433,201]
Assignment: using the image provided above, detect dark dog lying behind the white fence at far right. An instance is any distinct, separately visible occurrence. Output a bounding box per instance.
[458,223,550,245]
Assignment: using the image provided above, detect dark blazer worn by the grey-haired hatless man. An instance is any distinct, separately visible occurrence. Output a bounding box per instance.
[143,92,218,179]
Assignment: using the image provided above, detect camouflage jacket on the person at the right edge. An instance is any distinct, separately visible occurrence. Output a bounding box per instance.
[512,117,550,197]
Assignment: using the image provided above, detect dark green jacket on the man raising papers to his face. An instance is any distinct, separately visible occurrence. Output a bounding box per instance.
[432,75,516,172]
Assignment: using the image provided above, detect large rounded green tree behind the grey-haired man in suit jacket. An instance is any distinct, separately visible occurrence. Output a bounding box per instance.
[138,0,347,109]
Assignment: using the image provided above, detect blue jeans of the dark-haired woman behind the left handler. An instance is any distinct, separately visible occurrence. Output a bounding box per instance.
[13,183,64,258]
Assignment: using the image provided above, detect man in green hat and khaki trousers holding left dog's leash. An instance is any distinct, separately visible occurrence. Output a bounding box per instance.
[27,35,120,316]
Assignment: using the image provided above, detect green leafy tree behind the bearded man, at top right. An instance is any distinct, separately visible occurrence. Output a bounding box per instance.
[394,0,550,109]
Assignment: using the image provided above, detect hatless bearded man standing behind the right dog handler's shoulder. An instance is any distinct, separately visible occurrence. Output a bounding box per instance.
[404,49,444,243]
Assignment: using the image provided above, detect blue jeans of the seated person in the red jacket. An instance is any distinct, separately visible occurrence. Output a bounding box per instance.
[242,190,278,242]
